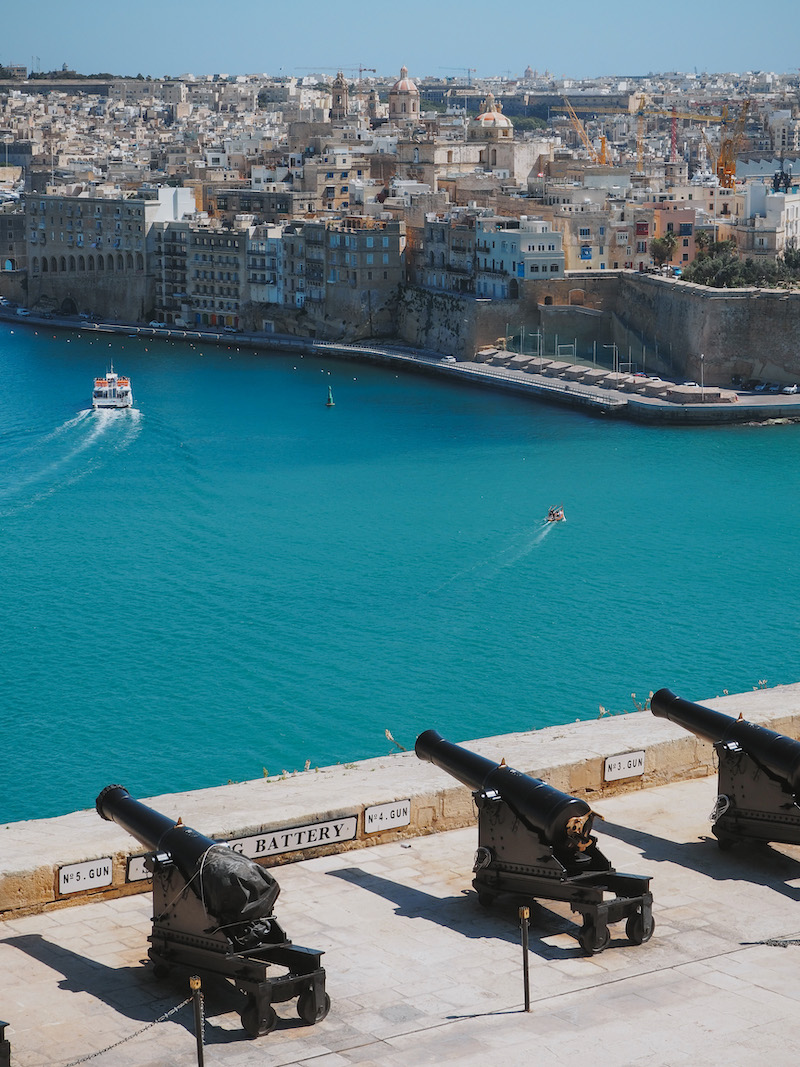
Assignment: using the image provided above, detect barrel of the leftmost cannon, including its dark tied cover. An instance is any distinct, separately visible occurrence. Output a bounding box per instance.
[96,785,281,925]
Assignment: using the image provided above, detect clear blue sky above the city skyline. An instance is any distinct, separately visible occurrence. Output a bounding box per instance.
[0,0,800,78]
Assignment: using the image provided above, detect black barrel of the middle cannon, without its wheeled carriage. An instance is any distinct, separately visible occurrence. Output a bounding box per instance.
[414,730,594,848]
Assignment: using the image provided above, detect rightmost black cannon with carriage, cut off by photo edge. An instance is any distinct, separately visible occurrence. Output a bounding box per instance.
[650,689,800,849]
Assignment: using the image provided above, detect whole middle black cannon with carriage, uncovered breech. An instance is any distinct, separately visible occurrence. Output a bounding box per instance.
[414,730,655,955]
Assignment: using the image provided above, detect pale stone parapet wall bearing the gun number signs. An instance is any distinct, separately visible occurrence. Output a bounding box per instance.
[6,684,800,919]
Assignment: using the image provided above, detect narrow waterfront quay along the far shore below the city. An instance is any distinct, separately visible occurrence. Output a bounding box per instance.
[6,307,800,426]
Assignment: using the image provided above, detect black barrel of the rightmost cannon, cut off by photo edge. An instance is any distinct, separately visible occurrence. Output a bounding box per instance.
[650,689,800,793]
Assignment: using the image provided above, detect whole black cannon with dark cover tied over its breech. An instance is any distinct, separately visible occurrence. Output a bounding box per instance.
[96,785,331,1037]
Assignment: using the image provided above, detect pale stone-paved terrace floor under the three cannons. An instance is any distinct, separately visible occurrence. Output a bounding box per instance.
[0,777,800,1067]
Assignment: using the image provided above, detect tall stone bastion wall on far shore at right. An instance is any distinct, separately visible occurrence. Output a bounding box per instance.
[397,271,800,386]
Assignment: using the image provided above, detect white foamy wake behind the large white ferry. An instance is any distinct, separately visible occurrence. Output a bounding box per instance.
[0,408,141,517]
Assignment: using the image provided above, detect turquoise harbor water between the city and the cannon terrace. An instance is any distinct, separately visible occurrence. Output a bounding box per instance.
[0,324,800,822]
